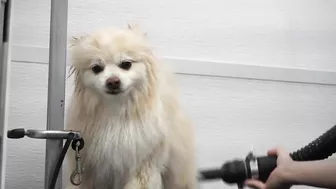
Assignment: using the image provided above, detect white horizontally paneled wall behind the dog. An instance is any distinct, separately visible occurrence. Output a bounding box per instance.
[6,0,336,189]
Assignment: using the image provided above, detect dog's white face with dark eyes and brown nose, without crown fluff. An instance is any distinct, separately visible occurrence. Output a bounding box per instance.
[82,52,146,95]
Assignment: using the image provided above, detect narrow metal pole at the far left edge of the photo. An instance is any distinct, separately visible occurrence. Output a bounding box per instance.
[0,0,12,189]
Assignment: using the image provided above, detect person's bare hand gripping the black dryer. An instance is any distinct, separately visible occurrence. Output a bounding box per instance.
[245,148,294,189]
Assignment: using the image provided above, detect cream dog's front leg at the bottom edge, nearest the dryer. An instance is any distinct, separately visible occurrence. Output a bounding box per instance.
[124,166,162,189]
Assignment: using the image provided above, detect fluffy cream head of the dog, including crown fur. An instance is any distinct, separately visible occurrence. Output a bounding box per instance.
[72,26,154,96]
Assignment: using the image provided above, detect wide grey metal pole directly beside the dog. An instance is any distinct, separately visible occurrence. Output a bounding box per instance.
[44,0,68,189]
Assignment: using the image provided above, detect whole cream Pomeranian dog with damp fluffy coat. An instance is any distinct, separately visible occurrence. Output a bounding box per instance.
[67,26,197,189]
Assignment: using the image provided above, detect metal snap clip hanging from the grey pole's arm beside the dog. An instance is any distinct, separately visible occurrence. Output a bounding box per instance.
[70,138,84,186]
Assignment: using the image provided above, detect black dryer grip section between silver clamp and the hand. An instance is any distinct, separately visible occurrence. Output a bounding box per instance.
[257,156,277,182]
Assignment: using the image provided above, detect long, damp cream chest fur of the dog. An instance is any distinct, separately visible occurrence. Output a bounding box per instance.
[70,108,167,188]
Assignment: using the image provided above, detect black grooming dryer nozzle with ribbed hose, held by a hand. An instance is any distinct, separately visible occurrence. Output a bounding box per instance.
[200,125,336,188]
